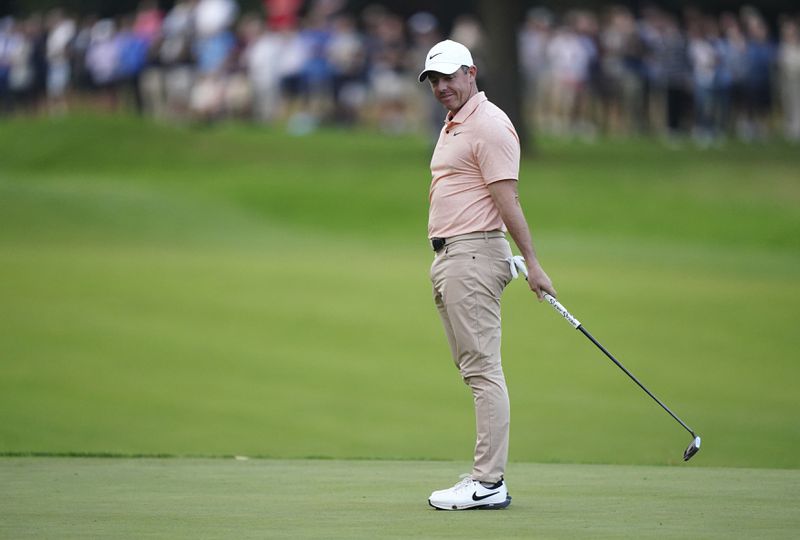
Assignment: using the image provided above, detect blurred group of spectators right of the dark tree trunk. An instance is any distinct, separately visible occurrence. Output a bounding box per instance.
[520,6,800,144]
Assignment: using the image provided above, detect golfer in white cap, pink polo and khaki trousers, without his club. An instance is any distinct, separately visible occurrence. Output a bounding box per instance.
[419,40,556,510]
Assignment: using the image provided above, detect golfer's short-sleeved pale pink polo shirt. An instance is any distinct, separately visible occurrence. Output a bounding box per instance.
[428,92,520,238]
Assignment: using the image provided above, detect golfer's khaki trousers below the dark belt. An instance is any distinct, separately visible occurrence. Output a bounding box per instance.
[431,235,511,482]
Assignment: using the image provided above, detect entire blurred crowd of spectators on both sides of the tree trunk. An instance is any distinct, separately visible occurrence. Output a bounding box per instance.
[0,0,800,145]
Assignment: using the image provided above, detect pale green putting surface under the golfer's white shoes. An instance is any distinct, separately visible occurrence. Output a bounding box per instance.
[0,458,800,540]
